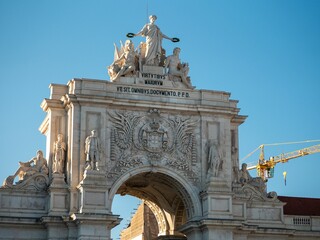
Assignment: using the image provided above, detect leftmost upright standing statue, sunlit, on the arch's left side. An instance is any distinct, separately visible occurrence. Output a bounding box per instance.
[52,134,66,174]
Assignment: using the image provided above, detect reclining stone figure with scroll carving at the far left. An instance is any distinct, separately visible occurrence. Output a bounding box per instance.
[2,150,49,190]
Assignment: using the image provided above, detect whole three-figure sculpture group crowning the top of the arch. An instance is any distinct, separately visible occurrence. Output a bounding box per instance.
[108,15,195,89]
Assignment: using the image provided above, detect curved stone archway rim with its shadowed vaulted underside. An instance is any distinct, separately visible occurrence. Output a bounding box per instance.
[109,166,201,235]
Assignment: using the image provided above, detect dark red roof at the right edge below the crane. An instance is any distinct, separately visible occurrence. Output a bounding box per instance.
[278,196,320,216]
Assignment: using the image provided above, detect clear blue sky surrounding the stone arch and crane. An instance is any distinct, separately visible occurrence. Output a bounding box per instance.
[0,0,320,238]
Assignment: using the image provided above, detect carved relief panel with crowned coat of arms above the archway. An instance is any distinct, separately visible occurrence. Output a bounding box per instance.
[108,109,199,180]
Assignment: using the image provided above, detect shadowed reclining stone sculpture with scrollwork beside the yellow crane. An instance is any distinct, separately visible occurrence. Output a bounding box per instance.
[233,163,279,201]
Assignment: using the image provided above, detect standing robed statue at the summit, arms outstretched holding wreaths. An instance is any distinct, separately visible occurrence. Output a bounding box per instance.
[131,15,179,66]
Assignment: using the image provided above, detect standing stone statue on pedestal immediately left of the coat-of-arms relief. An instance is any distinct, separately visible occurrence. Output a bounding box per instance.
[85,130,101,170]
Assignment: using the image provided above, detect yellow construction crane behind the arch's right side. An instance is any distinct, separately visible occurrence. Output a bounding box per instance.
[247,140,320,180]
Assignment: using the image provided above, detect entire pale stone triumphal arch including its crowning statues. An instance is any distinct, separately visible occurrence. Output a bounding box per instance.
[0,16,318,240]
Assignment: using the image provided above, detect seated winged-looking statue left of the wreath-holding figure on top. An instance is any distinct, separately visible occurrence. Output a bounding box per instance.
[108,40,139,82]
